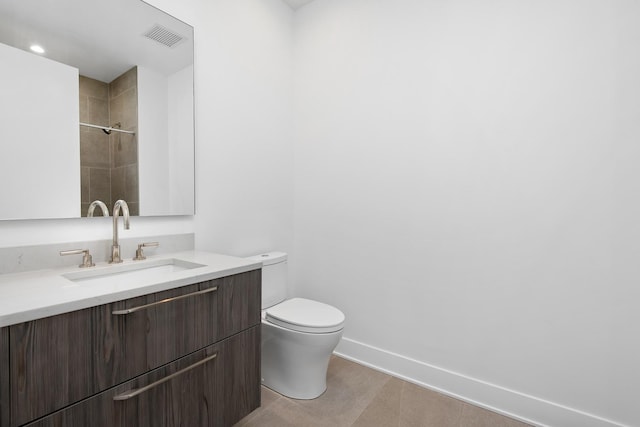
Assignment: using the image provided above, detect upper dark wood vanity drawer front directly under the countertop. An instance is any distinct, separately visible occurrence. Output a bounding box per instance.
[9,270,260,427]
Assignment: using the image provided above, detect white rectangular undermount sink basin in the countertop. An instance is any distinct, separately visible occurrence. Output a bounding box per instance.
[62,258,204,285]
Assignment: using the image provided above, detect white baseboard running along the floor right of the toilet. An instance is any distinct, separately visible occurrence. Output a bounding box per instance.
[335,338,629,427]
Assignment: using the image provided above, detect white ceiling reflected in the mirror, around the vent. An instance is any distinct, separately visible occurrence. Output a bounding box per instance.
[0,0,193,83]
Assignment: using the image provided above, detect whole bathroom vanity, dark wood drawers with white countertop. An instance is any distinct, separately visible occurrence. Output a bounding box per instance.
[0,252,261,427]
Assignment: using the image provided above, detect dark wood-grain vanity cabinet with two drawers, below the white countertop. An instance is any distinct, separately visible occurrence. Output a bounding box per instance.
[0,270,261,427]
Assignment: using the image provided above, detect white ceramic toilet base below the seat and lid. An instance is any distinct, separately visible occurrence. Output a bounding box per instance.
[261,320,342,400]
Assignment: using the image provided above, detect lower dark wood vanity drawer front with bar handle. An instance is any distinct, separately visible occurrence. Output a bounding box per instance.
[28,326,260,427]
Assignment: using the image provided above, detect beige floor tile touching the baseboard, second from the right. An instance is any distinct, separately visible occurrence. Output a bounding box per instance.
[399,382,463,427]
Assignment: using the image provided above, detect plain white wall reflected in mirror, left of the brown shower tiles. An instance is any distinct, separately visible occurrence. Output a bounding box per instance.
[0,43,80,218]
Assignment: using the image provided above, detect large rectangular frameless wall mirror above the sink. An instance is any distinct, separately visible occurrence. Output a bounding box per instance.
[0,0,194,220]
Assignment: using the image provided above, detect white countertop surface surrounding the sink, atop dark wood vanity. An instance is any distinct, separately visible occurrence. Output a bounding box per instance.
[0,251,262,327]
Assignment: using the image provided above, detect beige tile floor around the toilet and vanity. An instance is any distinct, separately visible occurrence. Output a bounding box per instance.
[235,356,528,427]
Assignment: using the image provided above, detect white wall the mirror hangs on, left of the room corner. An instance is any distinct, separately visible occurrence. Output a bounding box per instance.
[0,0,293,261]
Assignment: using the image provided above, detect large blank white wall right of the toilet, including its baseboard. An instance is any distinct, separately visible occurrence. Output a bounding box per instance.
[293,0,640,426]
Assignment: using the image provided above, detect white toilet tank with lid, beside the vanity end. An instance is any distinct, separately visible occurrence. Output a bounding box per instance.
[249,252,287,309]
